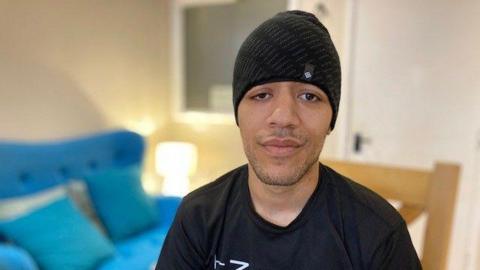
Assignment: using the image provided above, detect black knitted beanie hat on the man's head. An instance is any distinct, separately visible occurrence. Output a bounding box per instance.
[233,10,341,129]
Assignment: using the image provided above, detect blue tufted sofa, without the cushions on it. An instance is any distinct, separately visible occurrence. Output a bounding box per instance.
[0,130,181,270]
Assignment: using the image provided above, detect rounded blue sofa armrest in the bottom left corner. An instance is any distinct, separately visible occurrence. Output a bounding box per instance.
[0,243,38,270]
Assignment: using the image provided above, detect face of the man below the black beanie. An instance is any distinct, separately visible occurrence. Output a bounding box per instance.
[238,82,332,186]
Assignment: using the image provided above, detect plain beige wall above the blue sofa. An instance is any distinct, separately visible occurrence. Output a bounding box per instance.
[0,0,169,139]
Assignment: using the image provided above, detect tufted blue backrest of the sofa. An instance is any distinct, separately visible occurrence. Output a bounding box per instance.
[0,130,144,199]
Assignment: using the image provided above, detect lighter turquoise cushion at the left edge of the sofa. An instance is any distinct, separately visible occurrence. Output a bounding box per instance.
[0,197,114,270]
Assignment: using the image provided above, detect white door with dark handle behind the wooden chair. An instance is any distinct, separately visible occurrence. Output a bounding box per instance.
[342,0,480,269]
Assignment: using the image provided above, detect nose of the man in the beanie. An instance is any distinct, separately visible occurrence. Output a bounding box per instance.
[268,95,300,127]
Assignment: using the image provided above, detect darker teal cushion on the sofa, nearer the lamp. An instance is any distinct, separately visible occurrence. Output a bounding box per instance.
[85,165,157,241]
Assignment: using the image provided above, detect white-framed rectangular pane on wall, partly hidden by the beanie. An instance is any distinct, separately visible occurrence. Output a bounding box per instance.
[173,0,289,119]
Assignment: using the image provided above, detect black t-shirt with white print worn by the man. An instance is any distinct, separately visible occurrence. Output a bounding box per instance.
[156,165,421,270]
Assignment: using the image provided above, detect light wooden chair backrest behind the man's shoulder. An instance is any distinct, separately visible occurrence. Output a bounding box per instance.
[321,160,460,270]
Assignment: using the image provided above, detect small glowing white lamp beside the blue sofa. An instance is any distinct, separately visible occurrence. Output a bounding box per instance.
[155,142,197,196]
